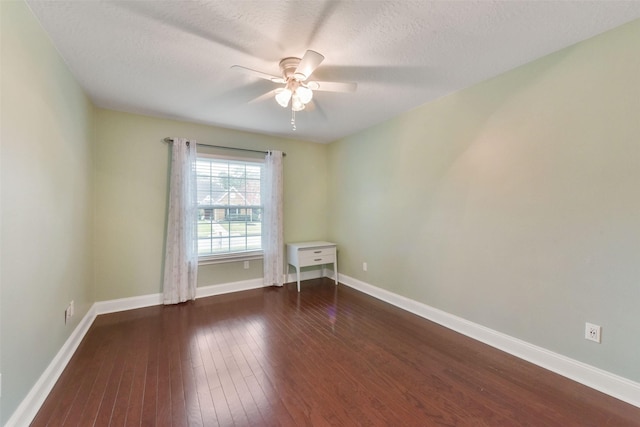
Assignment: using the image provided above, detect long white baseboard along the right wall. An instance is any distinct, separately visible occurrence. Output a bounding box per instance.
[338,274,640,408]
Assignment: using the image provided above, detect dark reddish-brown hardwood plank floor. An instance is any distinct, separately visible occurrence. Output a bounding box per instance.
[32,279,640,427]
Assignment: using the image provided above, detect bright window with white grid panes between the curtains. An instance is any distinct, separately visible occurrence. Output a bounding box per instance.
[196,154,263,261]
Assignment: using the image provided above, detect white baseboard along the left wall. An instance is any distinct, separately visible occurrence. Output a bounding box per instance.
[5,306,96,427]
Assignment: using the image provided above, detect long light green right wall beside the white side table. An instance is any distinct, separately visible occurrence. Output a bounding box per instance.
[329,21,640,381]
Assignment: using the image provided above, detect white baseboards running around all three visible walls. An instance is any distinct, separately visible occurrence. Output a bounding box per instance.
[17,269,640,427]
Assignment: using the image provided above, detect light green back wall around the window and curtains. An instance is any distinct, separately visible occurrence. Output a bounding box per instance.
[95,109,327,301]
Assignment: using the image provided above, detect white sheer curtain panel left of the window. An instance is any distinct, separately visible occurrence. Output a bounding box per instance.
[163,138,198,304]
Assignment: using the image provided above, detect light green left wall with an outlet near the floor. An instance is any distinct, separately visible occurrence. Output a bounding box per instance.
[0,1,94,424]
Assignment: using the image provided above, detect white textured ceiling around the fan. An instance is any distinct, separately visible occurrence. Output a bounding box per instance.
[27,0,640,142]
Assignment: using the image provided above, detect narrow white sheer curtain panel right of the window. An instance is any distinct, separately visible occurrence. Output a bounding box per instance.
[262,151,284,286]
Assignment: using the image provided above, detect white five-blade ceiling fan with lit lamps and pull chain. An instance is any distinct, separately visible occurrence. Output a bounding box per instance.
[231,50,358,130]
